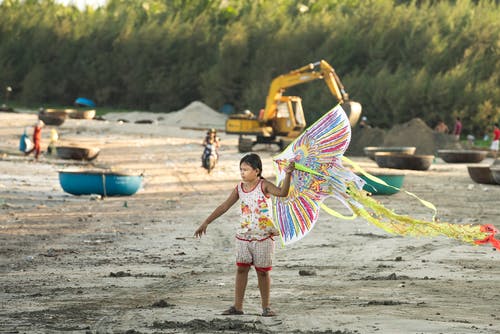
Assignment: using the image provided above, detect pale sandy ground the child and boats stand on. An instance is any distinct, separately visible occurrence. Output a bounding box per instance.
[0,108,500,334]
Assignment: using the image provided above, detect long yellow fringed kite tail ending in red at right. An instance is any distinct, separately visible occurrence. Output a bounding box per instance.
[348,187,500,250]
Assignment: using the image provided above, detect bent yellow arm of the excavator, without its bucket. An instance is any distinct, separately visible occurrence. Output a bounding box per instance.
[260,60,349,121]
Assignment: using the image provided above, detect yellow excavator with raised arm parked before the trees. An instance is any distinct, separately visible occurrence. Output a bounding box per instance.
[225,60,361,152]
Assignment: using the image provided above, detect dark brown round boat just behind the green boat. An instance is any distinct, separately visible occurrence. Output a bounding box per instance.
[375,152,434,170]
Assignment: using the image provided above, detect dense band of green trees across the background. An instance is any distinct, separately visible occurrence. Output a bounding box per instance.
[0,0,500,136]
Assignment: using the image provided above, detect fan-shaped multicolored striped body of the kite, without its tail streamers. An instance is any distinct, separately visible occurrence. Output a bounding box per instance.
[273,105,364,244]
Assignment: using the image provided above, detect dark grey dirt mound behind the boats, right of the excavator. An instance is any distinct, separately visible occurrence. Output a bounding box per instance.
[347,118,462,156]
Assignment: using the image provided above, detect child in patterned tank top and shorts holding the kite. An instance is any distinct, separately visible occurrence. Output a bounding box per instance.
[194,153,295,317]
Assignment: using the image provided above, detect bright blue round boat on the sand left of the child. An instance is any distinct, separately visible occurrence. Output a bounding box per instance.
[59,169,144,197]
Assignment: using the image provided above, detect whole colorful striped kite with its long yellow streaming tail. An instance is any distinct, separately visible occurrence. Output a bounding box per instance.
[273,105,500,250]
